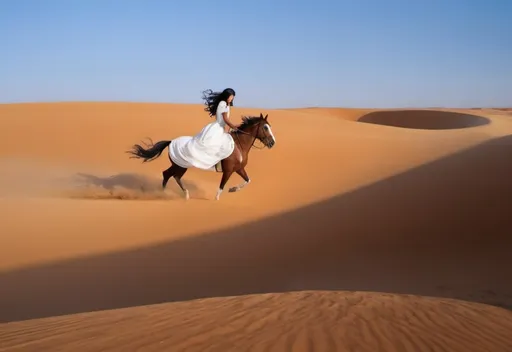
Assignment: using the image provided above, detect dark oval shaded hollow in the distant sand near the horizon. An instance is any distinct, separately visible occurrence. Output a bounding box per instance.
[357,110,490,130]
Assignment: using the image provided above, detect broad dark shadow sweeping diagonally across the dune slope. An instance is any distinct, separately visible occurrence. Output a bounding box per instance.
[0,136,512,322]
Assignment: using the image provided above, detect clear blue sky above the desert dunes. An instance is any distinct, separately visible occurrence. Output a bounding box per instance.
[0,0,512,108]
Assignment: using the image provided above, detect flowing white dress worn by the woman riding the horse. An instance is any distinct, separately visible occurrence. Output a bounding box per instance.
[169,101,235,170]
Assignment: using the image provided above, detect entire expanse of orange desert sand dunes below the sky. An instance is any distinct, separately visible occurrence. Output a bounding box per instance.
[0,102,512,352]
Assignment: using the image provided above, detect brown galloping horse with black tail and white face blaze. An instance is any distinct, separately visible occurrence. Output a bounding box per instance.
[128,113,276,200]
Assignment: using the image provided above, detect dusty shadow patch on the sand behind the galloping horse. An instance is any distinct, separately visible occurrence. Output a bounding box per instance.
[65,173,202,200]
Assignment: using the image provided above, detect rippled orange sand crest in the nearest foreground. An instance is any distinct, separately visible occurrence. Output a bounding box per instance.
[0,291,512,352]
